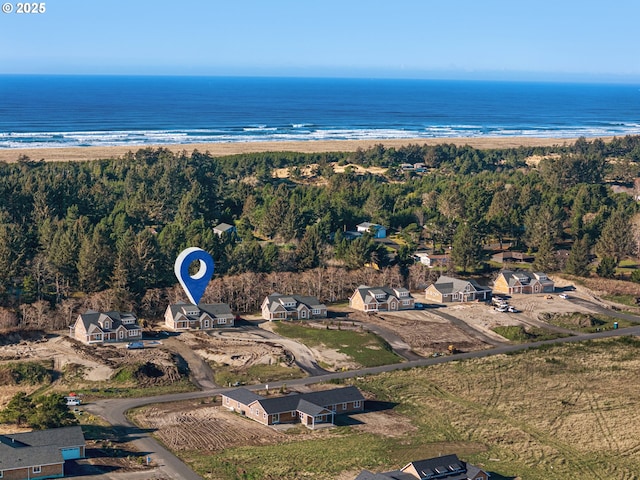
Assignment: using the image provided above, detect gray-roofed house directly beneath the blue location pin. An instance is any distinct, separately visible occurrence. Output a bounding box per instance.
[164,302,235,331]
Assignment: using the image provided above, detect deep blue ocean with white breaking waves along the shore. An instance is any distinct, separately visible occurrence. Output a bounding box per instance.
[0,75,640,148]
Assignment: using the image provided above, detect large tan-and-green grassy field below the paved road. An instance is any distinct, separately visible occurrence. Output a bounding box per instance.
[180,337,640,480]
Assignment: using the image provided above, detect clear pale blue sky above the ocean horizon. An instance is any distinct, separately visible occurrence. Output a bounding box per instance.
[0,0,640,82]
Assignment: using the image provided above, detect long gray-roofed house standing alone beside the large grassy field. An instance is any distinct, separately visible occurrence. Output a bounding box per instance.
[222,386,364,429]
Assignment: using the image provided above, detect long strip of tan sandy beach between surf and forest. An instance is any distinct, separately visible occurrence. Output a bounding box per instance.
[0,137,614,163]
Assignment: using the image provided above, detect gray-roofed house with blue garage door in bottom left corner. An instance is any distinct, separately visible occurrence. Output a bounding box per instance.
[0,426,85,480]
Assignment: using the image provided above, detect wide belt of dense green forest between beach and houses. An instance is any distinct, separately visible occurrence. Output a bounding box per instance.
[0,136,640,327]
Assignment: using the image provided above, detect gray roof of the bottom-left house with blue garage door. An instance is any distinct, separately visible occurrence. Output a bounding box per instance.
[0,426,85,470]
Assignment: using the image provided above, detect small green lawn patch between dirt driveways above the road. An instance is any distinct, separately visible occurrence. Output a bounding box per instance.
[274,322,402,367]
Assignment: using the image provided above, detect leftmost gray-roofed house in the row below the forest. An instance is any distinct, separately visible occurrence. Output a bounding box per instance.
[69,310,142,344]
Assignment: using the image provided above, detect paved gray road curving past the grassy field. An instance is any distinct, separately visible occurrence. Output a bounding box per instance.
[85,322,640,480]
